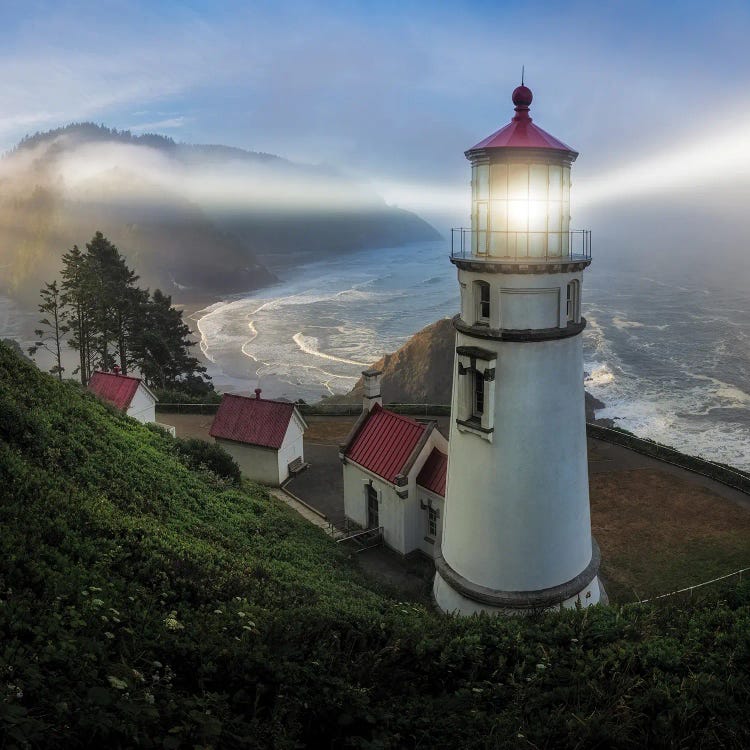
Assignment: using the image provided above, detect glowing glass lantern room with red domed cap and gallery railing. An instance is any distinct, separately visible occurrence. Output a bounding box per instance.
[452,84,590,262]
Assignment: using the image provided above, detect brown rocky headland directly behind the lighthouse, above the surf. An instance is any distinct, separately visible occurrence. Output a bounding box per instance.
[343,318,604,421]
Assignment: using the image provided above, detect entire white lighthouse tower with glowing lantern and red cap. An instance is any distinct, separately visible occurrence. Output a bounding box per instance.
[434,84,606,614]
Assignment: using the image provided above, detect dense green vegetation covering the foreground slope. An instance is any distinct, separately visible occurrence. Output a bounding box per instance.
[0,345,750,748]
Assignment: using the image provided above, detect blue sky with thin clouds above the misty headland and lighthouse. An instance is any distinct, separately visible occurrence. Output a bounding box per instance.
[0,0,750,220]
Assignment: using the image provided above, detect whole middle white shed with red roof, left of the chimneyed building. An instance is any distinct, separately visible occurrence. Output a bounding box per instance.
[209,388,307,487]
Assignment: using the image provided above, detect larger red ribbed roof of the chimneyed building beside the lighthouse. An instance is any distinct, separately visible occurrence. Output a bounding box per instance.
[344,404,427,482]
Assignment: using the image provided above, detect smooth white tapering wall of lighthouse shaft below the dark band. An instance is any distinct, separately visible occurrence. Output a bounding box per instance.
[443,334,591,591]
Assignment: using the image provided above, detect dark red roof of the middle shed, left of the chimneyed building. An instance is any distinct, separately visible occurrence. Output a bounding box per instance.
[209,393,294,448]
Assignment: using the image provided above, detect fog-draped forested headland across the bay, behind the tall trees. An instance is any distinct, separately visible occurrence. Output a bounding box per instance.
[0,123,438,306]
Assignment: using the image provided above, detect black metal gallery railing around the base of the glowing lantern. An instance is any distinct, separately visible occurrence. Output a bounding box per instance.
[451,227,591,263]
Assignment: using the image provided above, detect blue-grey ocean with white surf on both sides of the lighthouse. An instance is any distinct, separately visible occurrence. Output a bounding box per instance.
[193,242,750,469]
